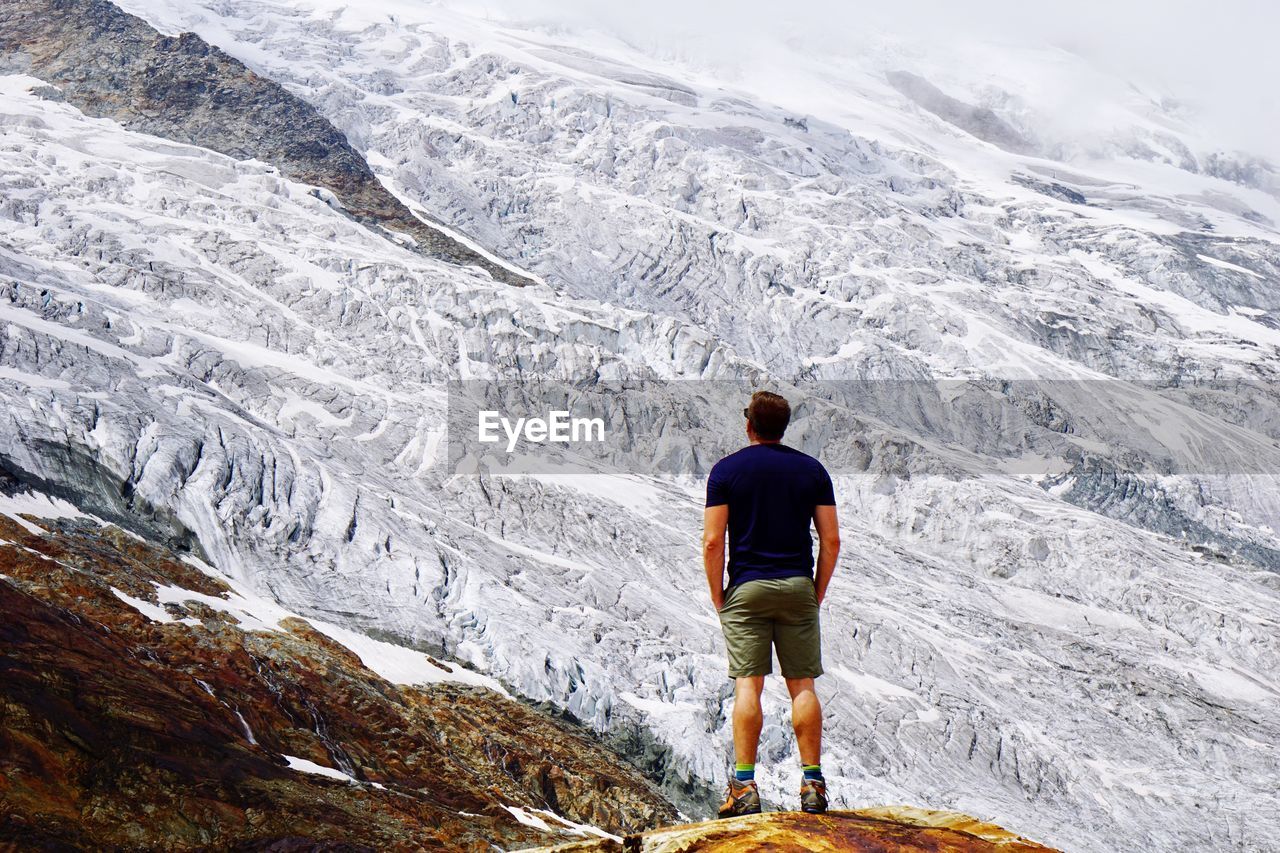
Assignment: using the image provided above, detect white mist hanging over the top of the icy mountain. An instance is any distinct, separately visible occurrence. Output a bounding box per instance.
[444,0,1280,163]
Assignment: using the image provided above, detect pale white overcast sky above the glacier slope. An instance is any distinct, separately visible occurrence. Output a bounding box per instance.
[445,0,1280,160]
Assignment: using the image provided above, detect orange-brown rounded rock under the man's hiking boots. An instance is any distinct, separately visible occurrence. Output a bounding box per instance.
[529,807,1052,853]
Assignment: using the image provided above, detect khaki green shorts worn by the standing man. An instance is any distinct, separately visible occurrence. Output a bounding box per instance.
[719,575,822,679]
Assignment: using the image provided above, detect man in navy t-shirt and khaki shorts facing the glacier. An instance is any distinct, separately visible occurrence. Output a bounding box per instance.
[703,391,840,817]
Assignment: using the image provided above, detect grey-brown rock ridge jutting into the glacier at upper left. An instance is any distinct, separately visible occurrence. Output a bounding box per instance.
[0,0,531,284]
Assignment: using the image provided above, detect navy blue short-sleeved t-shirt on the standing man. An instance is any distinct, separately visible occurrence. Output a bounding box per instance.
[707,444,836,587]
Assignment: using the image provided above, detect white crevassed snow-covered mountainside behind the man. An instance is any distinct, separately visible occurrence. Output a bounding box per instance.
[0,0,1280,850]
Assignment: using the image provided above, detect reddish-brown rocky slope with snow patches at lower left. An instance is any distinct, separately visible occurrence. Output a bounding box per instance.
[0,504,676,850]
